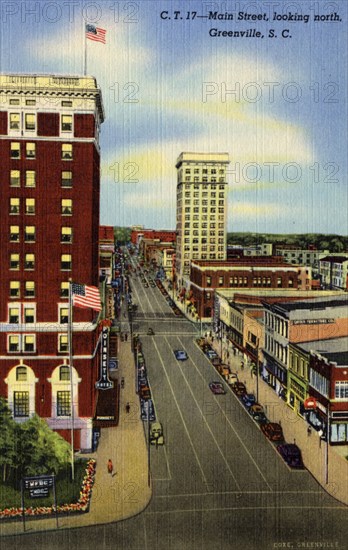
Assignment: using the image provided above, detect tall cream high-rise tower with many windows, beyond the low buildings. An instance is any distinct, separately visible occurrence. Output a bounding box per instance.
[175,152,229,287]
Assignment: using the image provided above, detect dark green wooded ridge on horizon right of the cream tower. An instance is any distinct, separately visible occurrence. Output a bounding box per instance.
[227,233,348,253]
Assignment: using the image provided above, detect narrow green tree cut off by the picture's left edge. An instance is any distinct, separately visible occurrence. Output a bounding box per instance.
[0,399,16,482]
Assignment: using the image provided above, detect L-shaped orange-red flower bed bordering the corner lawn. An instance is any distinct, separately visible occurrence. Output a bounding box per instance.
[0,459,96,520]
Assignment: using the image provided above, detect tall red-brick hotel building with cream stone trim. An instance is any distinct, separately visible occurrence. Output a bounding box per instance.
[0,75,104,449]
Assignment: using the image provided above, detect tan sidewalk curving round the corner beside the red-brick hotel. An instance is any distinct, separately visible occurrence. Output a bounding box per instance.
[0,341,152,535]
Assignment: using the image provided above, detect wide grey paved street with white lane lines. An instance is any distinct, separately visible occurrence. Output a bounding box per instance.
[1,266,348,550]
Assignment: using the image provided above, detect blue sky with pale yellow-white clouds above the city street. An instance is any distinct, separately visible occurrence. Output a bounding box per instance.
[0,0,348,234]
